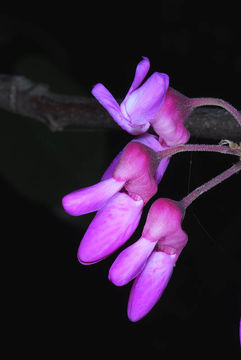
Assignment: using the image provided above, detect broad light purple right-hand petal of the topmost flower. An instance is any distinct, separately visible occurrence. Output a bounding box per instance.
[120,72,169,126]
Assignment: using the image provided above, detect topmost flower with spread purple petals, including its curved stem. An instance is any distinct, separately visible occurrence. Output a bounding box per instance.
[92,57,241,146]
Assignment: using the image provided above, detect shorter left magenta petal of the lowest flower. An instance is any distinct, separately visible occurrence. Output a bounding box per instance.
[109,237,156,286]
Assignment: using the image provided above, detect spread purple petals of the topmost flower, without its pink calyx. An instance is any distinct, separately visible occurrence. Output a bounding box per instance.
[92,57,169,135]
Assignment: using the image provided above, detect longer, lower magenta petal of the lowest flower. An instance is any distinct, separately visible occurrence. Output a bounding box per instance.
[128,251,173,321]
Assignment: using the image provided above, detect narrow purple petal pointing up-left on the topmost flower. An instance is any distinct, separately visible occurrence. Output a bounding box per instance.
[91,84,133,133]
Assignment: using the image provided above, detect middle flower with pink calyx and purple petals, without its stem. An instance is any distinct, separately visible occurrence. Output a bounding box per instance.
[63,134,169,265]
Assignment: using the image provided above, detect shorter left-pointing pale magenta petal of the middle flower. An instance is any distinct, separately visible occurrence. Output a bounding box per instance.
[62,178,125,216]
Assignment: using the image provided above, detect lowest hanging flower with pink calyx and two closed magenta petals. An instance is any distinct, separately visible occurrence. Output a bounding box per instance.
[109,198,187,321]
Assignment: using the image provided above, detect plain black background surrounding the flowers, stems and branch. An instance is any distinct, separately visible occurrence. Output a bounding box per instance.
[0,1,241,359]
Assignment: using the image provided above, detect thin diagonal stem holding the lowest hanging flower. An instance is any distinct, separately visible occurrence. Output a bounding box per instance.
[180,161,241,209]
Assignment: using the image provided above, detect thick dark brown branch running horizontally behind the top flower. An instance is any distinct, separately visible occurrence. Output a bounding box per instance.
[0,75,241,141]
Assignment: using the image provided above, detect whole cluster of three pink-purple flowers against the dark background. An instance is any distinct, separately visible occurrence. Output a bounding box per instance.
[63,57,240,321]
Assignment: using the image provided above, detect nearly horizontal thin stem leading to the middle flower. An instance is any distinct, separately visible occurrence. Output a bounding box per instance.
[159,144,241,160]
